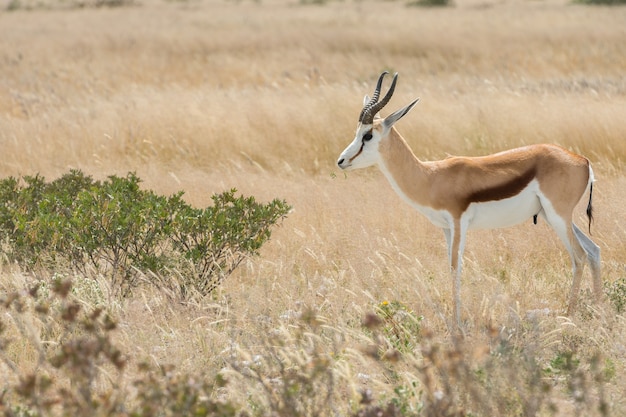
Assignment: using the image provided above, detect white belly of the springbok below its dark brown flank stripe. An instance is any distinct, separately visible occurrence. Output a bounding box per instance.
[463,181,541,229]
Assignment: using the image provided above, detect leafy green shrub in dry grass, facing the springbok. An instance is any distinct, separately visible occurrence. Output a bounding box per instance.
[0,170,290,297]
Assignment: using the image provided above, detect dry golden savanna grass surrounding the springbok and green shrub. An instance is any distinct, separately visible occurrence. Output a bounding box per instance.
[0,0,626,416]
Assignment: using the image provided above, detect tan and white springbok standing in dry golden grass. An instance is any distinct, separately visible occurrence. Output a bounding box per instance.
[337,71,602,324]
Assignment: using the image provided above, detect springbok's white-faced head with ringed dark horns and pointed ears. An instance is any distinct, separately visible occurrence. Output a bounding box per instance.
[337,71,419,170]
